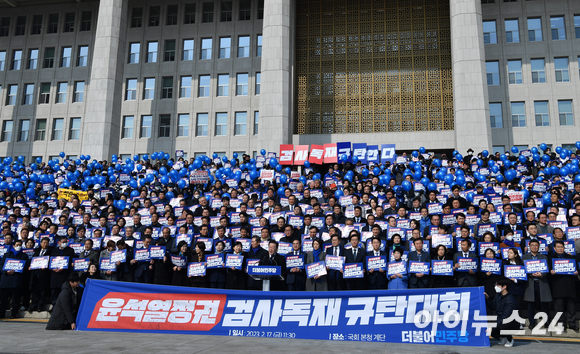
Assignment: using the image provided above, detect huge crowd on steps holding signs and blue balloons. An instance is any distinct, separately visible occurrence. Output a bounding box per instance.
[0,142,580,330]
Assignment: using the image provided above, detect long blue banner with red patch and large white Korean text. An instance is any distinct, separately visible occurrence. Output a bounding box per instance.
[76,279,489,346]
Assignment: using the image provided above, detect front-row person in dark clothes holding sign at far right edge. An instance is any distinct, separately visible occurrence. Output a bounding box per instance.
[548,241,578,331]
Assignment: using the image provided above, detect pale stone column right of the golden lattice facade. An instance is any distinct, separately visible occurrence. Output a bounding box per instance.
[449,0,492,154]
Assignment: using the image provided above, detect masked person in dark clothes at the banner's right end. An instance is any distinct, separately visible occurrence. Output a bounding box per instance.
[485,277,519,347]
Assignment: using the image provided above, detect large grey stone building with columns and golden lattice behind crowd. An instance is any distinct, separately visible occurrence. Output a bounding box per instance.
[0,0,580,162]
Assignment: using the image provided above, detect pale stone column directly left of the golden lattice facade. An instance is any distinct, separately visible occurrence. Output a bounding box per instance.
[258,0,294,152]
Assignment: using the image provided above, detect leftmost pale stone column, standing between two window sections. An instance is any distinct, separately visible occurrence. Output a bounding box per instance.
[81,0,128,160]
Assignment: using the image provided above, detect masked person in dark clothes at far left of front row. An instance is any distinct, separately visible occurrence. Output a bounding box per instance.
[0,240,28,318]
